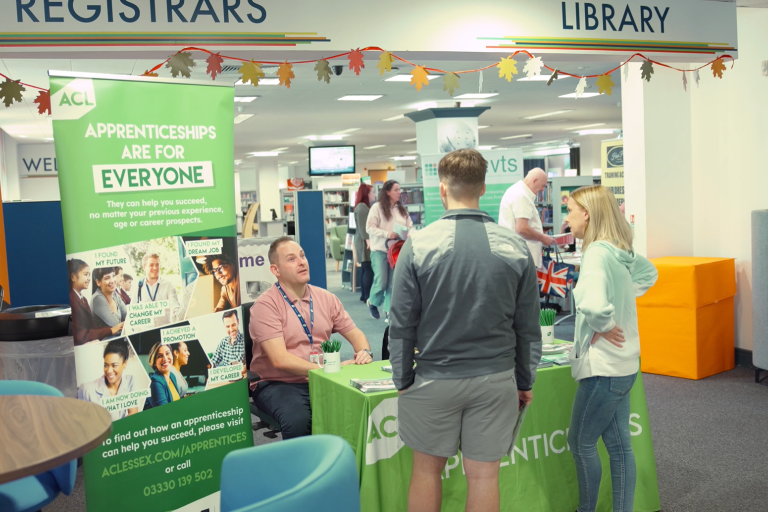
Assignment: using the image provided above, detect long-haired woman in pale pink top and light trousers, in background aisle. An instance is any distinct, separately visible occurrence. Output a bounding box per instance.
[365,180,413,320]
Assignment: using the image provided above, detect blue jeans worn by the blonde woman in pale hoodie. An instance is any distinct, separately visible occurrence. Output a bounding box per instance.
[568,374,637,512]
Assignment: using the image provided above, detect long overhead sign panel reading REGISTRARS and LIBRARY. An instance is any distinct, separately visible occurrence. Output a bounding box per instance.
[0,0,737,62]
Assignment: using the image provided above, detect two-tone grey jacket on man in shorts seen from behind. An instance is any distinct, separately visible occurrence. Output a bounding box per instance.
[389,210,541,391]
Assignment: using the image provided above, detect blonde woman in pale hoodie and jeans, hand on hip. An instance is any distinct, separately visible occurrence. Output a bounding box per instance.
[567,185,658,512]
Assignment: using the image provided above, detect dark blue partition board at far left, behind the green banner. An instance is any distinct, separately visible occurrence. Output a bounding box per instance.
[3,201,69,308]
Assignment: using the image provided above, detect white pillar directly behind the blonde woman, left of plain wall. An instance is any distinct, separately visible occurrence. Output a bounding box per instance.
[614,63,693,258]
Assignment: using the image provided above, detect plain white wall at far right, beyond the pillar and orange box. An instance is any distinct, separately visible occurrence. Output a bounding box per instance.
[691,8,768,350]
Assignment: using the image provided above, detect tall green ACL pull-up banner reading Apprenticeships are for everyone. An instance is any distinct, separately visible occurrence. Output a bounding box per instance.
[51,73,253,512]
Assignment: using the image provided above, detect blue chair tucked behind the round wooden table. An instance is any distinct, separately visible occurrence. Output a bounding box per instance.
[0,380,77,512]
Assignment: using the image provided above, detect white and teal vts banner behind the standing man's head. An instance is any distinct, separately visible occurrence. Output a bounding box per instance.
[421,149,523,225]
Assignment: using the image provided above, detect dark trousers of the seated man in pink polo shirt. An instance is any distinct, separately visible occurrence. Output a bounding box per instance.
[253,380,312,439]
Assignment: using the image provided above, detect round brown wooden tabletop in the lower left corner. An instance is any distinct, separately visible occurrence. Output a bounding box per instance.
[0,395,112,484]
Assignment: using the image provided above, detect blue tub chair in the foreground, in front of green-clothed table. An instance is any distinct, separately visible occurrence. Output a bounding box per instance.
[221,435,360,512]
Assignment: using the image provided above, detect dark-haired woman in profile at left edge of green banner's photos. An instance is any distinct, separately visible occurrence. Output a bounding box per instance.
[67,258,123,345]
